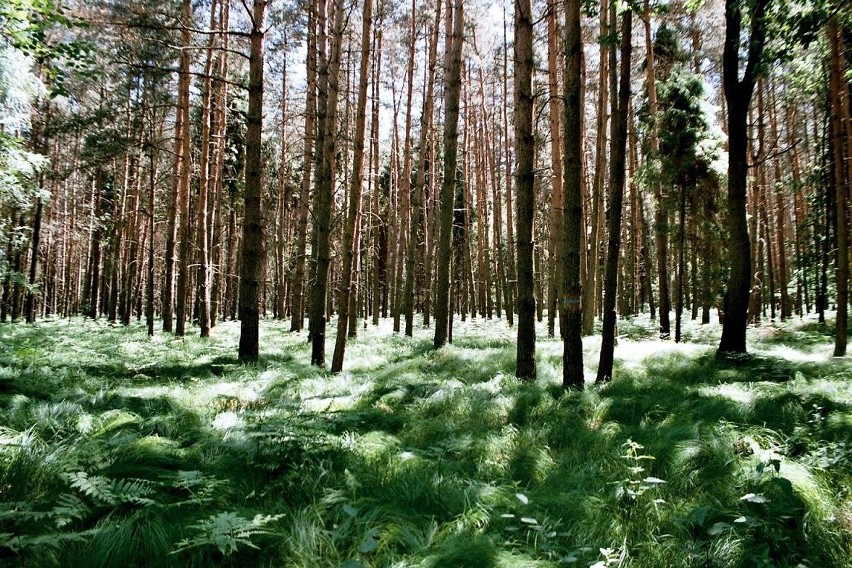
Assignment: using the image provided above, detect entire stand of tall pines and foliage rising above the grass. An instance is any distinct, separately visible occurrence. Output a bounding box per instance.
[0,0,852,380]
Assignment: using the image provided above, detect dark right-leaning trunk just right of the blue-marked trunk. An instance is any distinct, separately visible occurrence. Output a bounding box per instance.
[595,10,633,383]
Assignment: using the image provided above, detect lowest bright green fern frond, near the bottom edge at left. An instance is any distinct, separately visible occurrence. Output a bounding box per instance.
[173,511,284,556]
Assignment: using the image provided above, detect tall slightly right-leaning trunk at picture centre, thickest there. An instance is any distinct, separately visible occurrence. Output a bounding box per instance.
[434,0,464,349]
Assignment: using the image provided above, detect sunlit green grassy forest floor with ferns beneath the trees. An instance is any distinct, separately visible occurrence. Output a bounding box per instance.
[0,317,852,568]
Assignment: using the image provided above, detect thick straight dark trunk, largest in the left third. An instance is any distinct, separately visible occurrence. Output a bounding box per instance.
[237,0,267,363]
